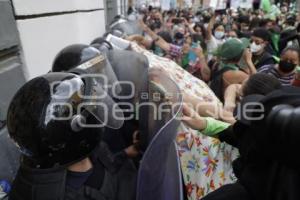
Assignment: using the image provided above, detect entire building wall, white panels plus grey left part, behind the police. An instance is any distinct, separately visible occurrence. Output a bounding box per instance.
[0,0,111,120]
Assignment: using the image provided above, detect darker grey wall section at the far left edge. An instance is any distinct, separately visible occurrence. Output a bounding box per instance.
[0,0,25,120]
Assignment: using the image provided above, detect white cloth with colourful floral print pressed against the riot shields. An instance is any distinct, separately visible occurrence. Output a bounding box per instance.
[131,43,238,200]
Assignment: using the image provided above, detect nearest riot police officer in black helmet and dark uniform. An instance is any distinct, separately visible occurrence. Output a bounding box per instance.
[7,70,129,200]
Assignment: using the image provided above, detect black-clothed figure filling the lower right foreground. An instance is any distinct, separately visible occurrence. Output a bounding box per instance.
[203,88,300,200]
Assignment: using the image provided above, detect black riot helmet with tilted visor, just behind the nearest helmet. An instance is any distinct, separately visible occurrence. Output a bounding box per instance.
[52,44,121,96]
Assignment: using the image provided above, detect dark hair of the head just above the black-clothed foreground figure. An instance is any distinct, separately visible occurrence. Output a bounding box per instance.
[243,73,281,96]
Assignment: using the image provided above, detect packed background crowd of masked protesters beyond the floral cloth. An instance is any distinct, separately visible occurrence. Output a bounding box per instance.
[130,4,300,93]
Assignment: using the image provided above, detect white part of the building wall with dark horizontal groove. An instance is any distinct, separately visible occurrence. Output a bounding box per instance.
[13,0,105,79]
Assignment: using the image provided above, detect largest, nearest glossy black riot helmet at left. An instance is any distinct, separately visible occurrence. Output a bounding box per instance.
[7,73,121,169]
